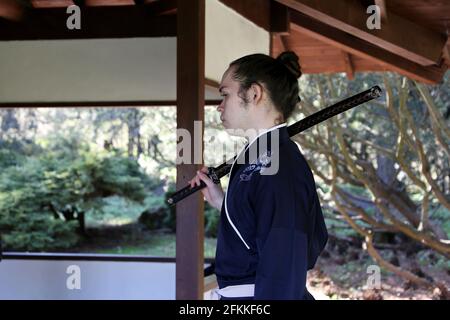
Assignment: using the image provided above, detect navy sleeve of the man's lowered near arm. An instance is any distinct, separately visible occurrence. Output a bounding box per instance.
[250,175,311,300]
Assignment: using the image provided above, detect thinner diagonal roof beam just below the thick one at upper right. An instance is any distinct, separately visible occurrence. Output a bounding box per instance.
[291,11,447,84]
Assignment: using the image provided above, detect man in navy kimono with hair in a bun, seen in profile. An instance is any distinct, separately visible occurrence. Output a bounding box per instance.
[190,52,328,300]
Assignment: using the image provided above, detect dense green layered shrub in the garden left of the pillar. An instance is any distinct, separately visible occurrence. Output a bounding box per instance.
[0,132,160,250]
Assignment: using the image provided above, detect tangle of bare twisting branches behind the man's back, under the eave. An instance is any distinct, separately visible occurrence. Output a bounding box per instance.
[295,72,450,285]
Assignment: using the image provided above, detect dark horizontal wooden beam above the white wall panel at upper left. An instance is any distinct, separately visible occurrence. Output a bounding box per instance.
[0,5,177,40]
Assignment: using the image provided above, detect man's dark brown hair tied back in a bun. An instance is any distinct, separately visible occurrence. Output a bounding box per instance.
[230,51,302,120]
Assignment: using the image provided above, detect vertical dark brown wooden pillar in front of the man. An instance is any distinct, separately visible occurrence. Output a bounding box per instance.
[176,0,205,300]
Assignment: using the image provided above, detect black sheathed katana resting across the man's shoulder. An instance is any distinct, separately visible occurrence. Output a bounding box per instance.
[166,86,381,206]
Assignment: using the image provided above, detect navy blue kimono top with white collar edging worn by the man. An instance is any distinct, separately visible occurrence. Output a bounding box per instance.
[215,124,328,299]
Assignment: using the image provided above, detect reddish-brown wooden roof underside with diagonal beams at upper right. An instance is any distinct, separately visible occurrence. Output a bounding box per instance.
[272,0,450,83]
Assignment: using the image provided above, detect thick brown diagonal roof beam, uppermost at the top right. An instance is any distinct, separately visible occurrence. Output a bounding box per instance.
[277,0,446,66]
